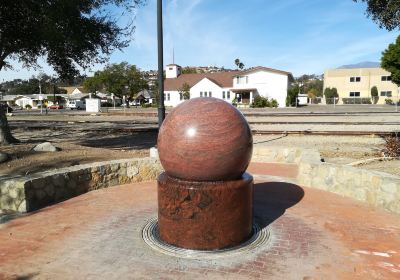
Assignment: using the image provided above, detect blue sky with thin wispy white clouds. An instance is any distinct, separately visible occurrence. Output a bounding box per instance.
[0,0,399,81]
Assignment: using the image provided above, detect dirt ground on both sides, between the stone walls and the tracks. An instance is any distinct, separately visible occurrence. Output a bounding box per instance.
[0,127,400,176]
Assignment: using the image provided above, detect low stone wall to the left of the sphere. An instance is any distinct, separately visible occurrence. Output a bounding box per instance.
[0,158,162,212]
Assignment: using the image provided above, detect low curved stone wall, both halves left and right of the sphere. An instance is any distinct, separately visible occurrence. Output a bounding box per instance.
[0,145,400,214]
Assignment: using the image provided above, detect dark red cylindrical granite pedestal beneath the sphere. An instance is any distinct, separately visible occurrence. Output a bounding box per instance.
[158,173,253,250]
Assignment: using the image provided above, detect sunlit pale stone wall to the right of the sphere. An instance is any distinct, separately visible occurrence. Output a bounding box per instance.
[253,146,400,214]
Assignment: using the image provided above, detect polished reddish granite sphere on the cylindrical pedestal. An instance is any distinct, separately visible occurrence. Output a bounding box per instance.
[157,97,253,181]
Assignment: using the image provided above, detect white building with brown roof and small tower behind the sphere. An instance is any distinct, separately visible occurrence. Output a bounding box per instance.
[164,64,293,107]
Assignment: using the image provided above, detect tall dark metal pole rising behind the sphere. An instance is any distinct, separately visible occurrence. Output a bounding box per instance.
[157,0,165,127]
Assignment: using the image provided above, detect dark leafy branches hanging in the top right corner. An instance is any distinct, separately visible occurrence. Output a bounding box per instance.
[353,0,400,31]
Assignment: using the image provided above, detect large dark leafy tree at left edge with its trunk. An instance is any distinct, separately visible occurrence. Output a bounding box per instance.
[0,0,143,144]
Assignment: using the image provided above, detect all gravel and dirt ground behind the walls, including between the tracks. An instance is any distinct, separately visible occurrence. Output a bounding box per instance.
[0,108,400,175]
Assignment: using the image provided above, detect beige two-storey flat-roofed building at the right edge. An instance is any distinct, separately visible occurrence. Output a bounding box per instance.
[324,68,398,104]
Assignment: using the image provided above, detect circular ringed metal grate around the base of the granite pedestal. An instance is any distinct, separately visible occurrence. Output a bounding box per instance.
[142,218,271,259]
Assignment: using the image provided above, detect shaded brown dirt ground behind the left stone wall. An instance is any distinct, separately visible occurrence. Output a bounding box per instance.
[0,129,157,176]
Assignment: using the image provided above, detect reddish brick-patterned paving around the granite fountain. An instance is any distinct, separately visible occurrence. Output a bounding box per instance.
[0,163,400,280]
